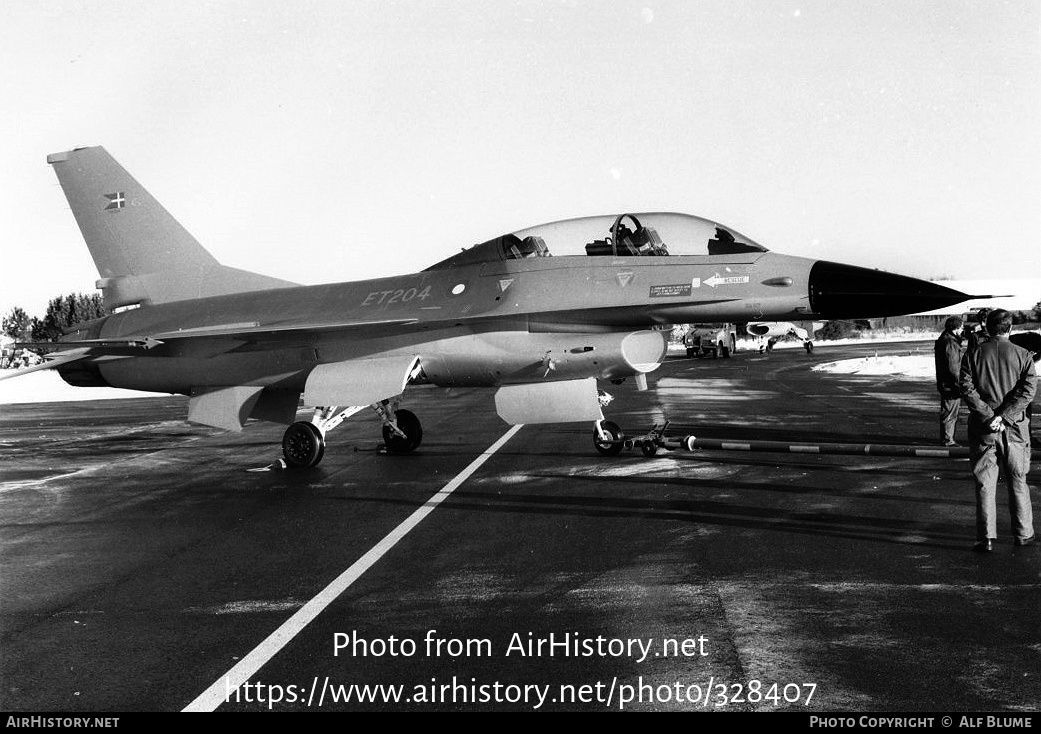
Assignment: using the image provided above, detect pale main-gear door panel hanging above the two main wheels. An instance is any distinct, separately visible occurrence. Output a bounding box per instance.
[304,355,420,406]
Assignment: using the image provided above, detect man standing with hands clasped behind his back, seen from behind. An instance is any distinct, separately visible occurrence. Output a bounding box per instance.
[961,308,1037,553]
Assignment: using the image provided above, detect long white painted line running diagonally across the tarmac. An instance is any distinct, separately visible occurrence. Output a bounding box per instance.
[183,426,523,711]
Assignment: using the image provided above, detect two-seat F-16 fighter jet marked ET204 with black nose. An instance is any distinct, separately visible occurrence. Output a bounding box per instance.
[2,148,970,466]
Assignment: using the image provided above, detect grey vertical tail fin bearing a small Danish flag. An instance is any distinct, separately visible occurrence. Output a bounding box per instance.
[47,147,295,308]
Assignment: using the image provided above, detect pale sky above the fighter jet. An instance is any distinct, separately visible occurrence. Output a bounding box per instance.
[0,0,1041,315]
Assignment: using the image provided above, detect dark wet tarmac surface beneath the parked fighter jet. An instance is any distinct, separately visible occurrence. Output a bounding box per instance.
[0,345,1041,712]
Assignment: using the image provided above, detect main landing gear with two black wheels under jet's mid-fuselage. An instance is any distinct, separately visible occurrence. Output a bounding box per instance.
[282,400,423,469]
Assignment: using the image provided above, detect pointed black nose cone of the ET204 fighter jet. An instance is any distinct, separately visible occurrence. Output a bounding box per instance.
[810,260,971,319]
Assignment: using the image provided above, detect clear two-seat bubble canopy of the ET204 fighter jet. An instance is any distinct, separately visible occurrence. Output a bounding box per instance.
[428,211,766,270]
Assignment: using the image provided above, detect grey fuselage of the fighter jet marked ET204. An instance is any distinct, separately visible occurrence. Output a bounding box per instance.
[60,248,814,394]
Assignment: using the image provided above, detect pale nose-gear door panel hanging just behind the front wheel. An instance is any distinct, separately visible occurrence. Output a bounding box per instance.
[496,377,604,426]
